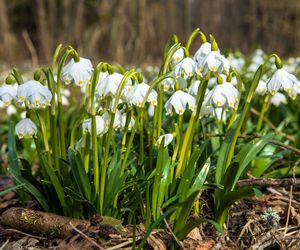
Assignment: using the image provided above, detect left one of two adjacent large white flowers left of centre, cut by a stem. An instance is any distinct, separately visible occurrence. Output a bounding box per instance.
[97,72,132,98]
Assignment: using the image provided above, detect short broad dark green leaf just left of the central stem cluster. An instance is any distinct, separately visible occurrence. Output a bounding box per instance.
[68,149,91,201]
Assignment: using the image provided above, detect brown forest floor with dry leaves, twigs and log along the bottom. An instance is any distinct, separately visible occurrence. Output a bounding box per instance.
[0,177,300,250]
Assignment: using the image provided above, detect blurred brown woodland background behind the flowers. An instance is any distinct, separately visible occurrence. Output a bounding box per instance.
[0,0,300,66]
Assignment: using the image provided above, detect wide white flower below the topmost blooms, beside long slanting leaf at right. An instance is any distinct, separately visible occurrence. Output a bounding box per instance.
[207,82,239,108]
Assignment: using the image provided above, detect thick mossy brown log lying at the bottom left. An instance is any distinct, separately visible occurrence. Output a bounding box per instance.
[0,208,90,238]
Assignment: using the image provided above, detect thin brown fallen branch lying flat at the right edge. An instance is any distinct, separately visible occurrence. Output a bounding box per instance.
[237,178,300,187]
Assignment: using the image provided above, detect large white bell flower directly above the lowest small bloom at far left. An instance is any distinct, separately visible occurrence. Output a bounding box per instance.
[16,80,52,108]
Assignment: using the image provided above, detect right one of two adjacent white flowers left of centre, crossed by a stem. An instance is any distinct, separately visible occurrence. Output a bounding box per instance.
[127,82,157,107]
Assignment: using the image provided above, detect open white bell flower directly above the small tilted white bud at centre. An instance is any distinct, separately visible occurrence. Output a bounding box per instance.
[165,90,196,115]
